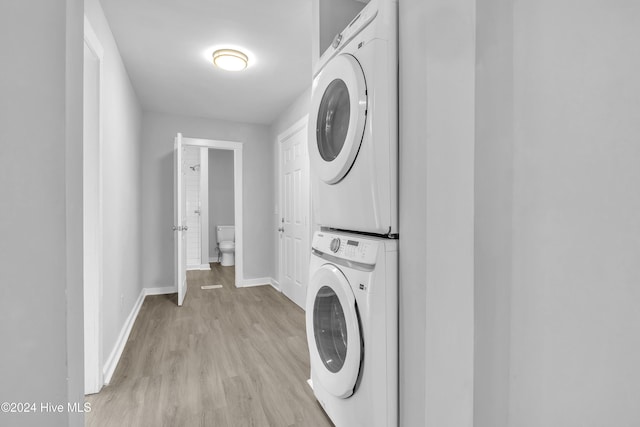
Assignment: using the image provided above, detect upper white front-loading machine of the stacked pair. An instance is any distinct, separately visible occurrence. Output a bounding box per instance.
[308,0,398,236]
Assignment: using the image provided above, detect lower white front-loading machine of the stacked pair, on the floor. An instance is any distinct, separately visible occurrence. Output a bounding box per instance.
[305,231,398,427]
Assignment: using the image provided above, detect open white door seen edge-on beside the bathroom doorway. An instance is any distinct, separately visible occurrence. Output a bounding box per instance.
[173,133,188,306]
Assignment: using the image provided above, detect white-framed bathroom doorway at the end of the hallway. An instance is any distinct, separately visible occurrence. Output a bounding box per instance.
[176,137,244,286]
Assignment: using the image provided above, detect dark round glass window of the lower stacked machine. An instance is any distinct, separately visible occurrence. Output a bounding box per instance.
[313,286,347,373]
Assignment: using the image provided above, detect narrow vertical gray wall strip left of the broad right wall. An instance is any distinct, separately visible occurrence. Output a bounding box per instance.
[474,0,514,427]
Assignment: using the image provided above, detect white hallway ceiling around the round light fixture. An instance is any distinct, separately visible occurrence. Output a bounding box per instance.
[100,0,311,124]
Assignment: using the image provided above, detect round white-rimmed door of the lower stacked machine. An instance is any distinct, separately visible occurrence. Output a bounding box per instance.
[306,264,362,398]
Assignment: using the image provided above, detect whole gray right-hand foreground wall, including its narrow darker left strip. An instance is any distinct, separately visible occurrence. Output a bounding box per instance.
[474,0,640,427]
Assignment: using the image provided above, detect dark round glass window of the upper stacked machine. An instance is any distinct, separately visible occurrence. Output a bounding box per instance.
[316,79,351,162]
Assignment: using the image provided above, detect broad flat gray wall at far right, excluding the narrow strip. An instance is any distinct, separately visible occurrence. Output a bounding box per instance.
[509,0,640,427]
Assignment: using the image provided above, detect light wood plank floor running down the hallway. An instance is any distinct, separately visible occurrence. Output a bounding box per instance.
[86,264,332,427]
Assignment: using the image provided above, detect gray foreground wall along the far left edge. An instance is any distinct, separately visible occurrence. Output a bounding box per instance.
[0,0,84,426]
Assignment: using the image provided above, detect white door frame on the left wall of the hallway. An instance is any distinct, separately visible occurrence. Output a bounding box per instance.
[83,15,104,394]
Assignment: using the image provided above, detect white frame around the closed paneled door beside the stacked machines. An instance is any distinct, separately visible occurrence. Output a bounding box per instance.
[276,114,313,309]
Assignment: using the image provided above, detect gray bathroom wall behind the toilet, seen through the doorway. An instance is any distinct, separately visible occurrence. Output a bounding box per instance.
[208,149,235,261]
